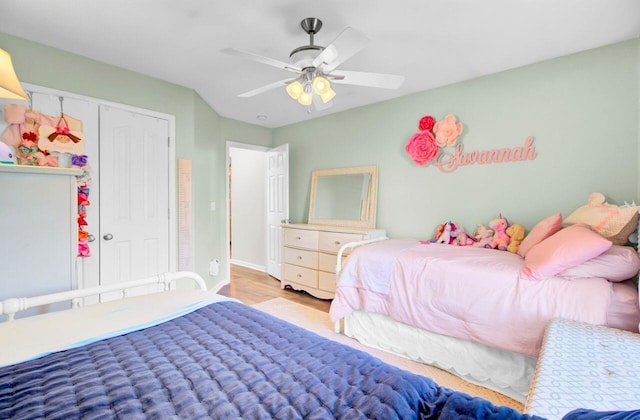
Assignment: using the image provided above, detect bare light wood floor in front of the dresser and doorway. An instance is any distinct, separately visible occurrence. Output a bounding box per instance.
[218,265,331,313]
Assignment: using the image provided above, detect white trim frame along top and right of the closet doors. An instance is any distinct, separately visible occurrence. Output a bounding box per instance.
[22,83,178,288]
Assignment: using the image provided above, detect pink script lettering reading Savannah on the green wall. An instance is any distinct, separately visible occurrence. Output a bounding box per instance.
[435,136,538,172]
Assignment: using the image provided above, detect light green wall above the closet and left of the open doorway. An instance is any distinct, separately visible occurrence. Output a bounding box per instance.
[0,33,272,287]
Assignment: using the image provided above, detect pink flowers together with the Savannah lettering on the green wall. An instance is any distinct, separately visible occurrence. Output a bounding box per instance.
[405,114,537,172]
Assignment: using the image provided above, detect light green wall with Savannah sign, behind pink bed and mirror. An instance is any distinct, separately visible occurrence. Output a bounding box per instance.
[274,40,639,238]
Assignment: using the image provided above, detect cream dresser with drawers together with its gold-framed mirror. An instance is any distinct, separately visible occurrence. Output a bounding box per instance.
[280,166,386,299]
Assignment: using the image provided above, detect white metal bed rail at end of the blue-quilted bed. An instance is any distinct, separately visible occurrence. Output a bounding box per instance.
[0,271,207,322]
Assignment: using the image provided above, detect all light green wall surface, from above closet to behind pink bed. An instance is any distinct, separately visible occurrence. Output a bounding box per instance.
[0,33,640,286]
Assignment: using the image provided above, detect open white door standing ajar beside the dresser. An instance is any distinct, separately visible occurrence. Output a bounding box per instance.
[266,144,289,280]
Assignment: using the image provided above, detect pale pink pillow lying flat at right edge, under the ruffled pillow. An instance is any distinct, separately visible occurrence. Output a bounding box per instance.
[558,245,640,282]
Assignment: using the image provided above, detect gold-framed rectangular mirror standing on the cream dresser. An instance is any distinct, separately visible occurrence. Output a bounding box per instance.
[309,166,378,229]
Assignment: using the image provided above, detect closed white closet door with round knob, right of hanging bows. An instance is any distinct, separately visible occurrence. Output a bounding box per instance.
[99,106,170,300]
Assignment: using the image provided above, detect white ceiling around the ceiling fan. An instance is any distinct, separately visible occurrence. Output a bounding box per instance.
[0,0,640,127]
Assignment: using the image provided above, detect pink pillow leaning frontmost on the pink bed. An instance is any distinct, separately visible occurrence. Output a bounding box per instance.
[520,224,611,280]
